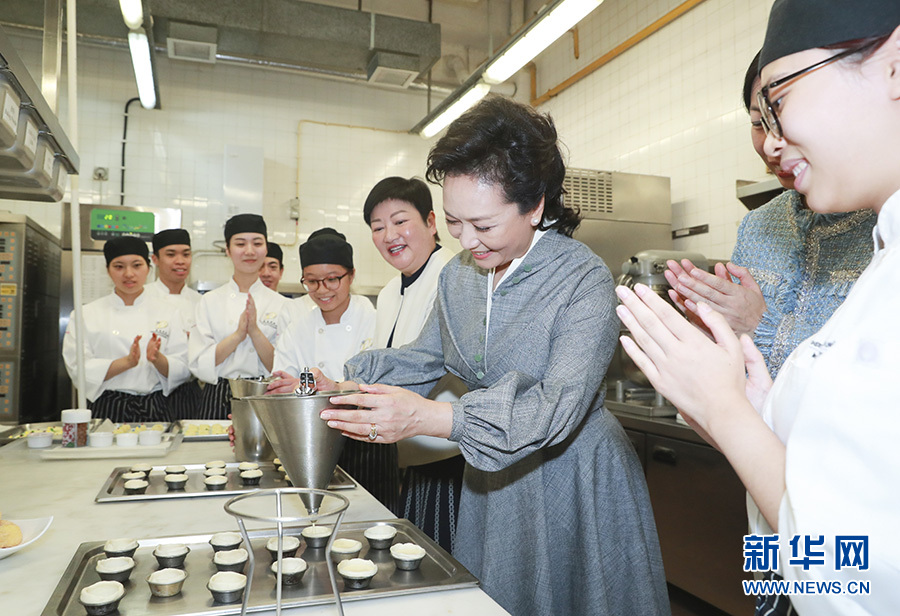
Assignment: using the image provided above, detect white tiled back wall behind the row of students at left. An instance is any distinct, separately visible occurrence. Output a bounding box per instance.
[0,36,458,287]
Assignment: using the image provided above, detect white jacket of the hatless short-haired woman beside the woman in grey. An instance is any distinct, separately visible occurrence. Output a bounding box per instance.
[375,246,467,467]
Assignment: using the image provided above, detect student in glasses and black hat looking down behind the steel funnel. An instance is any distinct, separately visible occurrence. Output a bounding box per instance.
[270,227,388,510]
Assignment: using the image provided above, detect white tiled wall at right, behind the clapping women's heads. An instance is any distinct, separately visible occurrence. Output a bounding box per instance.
[537,0,772,258]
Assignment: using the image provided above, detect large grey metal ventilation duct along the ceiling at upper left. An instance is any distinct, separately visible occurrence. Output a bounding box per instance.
[0,0,441,87]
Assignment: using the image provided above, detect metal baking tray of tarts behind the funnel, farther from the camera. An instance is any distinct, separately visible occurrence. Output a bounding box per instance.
[94,462,356,503]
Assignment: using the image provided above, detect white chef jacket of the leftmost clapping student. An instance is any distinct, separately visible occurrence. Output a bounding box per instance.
[63,290,190,400]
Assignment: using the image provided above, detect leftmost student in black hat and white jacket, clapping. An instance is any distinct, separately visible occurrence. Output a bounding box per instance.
[63,236,190,423]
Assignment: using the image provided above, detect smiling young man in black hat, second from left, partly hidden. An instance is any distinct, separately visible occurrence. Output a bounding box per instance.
[146,229,200,419]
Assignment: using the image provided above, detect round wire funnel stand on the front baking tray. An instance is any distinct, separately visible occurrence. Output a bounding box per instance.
[225,488,350,616]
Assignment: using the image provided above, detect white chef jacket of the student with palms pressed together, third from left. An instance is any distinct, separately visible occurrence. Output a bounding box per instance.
[188,278,288,383]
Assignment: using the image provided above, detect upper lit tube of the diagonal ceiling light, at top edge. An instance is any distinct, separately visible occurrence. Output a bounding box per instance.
[484,0,603,83]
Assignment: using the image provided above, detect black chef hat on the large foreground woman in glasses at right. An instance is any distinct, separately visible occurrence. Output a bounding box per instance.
[759,0,900,68]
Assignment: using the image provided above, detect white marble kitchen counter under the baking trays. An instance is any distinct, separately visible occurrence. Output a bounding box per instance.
[0,440,507,616]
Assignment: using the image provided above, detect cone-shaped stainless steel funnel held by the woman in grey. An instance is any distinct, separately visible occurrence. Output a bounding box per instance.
[243,391,357,513]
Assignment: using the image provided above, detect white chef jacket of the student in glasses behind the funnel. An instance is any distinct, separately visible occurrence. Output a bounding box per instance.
[274,295,375,380]
